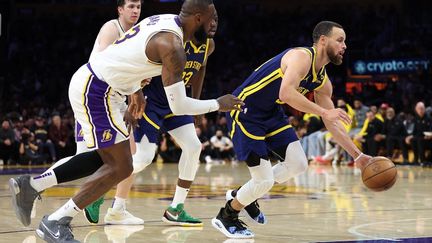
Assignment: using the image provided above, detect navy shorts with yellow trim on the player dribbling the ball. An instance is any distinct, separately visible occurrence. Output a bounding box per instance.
[226,112,298,161]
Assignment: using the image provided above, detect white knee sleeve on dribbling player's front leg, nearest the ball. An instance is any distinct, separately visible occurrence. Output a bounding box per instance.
[273,141,308,183]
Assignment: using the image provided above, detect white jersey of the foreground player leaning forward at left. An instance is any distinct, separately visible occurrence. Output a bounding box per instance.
[90,14,183,95]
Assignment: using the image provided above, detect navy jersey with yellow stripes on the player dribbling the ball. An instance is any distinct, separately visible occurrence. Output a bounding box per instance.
[230,47,326,120]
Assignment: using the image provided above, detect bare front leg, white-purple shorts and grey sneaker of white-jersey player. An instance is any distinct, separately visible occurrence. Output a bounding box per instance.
[37,64,133,241]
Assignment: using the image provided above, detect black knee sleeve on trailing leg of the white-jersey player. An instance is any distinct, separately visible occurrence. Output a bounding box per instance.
[53,150,103,184]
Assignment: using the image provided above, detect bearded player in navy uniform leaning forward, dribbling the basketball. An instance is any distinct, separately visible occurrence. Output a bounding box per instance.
[212,21,371,238]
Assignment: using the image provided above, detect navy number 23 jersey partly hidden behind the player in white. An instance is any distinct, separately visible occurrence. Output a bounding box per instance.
[143,39,209,113]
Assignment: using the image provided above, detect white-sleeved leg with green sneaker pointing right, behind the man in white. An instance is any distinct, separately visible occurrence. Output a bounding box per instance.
[162,122,202,226]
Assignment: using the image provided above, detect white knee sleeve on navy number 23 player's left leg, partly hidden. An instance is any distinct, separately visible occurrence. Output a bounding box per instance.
[132,136,157,174]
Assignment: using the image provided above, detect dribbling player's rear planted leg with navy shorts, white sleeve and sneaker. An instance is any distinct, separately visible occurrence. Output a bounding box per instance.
[212,116,268,238]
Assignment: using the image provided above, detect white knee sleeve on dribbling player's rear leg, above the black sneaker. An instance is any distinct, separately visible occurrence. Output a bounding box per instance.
[237,159,274,206]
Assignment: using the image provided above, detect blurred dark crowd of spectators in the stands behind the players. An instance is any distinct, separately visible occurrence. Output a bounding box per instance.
[0,0,432,164]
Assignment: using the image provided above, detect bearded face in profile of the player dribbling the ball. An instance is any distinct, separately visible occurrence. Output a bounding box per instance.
[326,27,347,65]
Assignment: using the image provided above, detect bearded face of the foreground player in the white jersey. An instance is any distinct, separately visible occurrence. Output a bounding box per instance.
[194,4,218,43]
